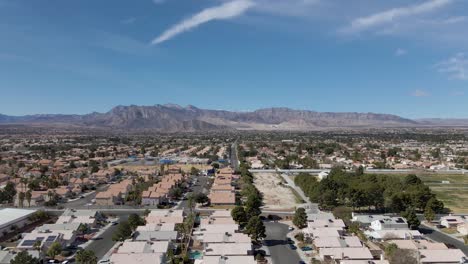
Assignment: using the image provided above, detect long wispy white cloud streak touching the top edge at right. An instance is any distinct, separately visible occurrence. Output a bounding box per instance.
[343,0,454,33]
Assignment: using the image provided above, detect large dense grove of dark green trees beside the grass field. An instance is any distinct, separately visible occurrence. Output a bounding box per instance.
[294,167,445,218]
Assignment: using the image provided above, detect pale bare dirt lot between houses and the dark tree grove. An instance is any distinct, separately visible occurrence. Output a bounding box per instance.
[254,173,297,211]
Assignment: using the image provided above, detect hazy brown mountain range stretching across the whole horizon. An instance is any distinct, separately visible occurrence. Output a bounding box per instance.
[0,104,468,132]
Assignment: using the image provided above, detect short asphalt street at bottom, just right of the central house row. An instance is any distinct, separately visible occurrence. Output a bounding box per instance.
[263,222,301,264]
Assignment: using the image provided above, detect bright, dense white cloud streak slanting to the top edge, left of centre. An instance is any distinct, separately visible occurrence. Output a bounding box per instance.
[151,0,255,44]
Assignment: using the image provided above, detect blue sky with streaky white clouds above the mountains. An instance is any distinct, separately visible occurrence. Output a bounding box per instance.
[0,0,468,118]
